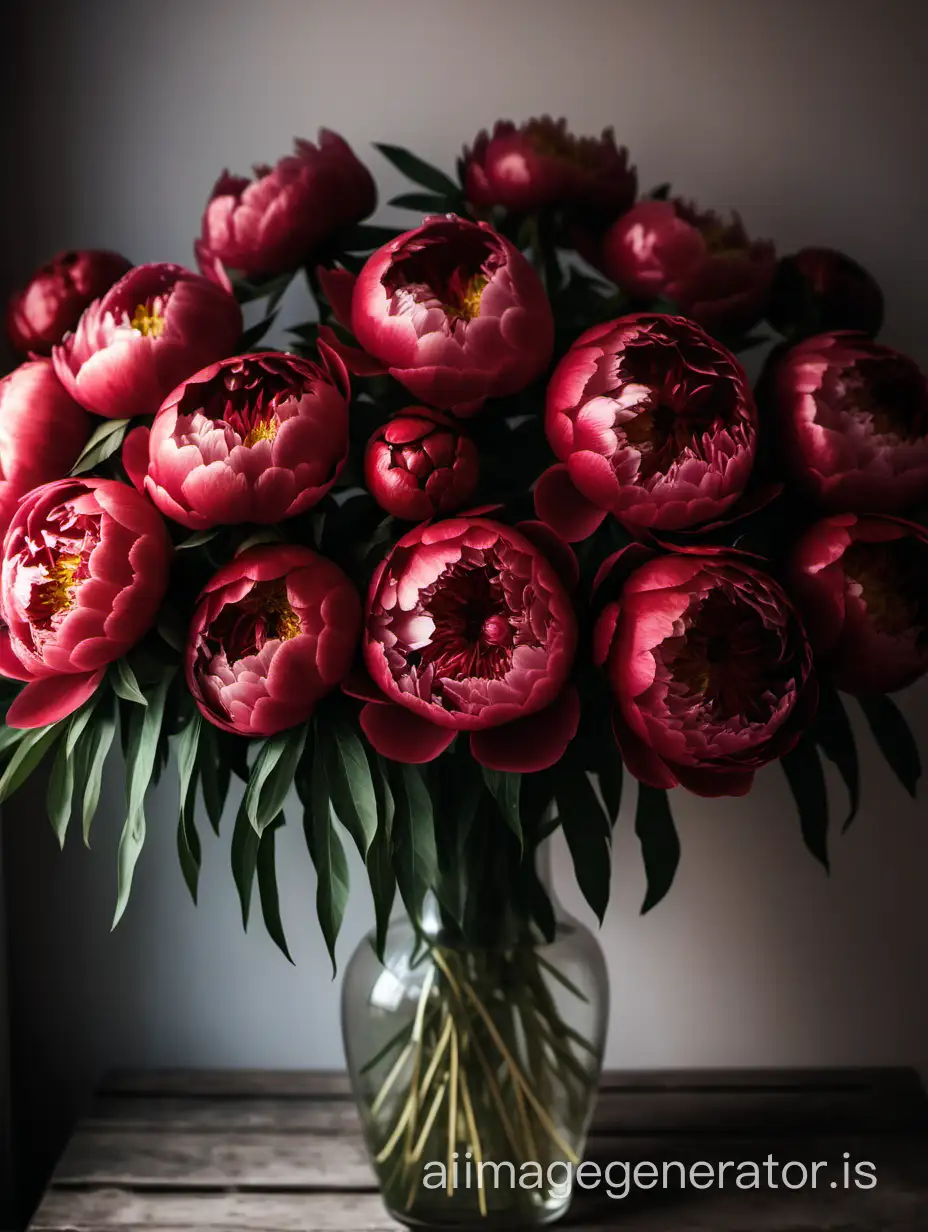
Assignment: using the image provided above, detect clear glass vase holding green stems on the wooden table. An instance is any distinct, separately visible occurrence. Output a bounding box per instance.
[343,891,609,1228]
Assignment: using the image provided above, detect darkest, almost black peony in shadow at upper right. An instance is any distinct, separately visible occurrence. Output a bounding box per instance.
[767,248,882,338]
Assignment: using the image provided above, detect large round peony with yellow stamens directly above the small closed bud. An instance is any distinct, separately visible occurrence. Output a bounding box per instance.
[351,214,555,414]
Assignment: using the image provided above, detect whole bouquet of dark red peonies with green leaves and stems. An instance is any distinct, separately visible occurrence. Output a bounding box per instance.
[0,117,928,1214]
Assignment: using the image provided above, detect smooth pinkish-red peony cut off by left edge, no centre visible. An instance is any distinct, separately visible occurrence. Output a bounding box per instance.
[0,360,90,537]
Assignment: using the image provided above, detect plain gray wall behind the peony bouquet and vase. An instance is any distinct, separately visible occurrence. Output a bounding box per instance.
[1,0,928,1222]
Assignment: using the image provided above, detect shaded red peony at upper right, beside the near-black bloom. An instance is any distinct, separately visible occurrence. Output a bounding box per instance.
[598,198,776,334]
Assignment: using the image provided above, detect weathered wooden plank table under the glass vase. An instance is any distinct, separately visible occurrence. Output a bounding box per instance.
[31,1069,928,1232]
